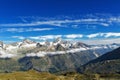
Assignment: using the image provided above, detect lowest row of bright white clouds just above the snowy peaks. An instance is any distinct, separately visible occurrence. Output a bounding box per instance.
[12,32,120,40]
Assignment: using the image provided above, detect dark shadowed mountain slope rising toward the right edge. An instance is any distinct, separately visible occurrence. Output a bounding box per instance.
[81,47,120,73]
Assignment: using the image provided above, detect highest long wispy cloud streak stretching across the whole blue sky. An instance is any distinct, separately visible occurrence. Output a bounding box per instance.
[0,16,120,27]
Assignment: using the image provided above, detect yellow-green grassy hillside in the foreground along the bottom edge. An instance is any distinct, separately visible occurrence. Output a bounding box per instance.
[0,70,120,80]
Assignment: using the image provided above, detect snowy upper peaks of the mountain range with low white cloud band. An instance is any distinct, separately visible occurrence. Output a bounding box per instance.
[0,38,120,58]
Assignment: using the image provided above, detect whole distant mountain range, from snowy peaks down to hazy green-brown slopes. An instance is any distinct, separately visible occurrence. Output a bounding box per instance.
[0,38,120,72]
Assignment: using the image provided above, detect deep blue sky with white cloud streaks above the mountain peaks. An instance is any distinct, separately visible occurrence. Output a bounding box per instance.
[0,0,120,44]
